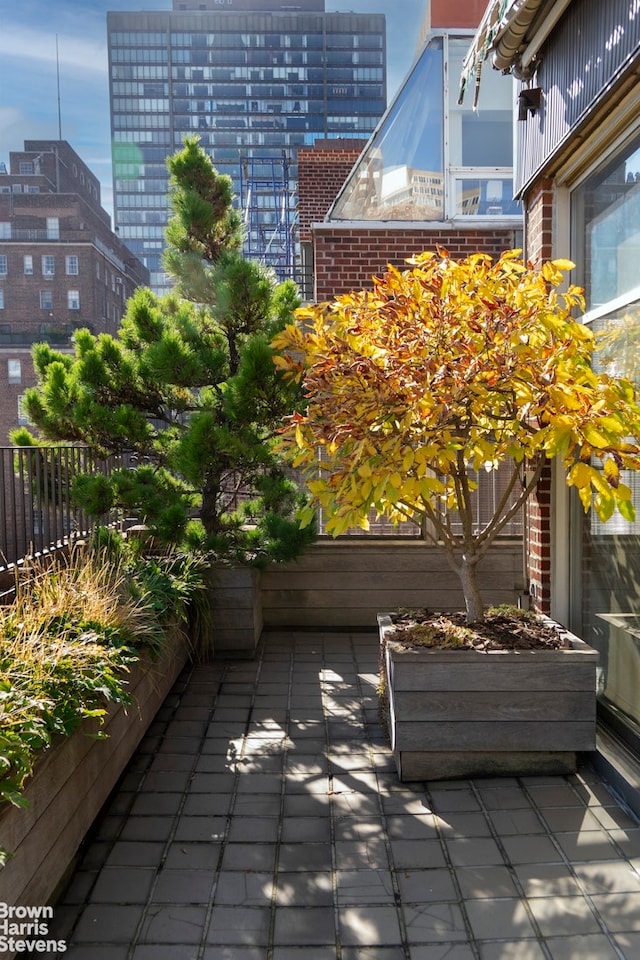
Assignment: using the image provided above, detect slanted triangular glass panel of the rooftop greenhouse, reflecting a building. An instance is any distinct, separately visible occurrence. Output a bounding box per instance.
[330,37,444,220]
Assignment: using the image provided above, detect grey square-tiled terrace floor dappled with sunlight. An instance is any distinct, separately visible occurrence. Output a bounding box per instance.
[48,633,640,960]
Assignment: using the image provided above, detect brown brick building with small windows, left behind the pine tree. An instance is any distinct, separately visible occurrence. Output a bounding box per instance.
[0,140,149,445]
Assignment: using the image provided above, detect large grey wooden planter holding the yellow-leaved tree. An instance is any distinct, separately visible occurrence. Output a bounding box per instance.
[378,614,598,780]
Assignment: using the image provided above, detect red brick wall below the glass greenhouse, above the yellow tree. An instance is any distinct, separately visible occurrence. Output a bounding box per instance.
[314,224,516,301]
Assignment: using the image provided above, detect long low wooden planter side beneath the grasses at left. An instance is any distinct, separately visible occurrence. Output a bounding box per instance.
[0,631,187,906]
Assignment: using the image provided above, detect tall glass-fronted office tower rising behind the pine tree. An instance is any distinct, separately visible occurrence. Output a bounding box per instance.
[107,0,386,290]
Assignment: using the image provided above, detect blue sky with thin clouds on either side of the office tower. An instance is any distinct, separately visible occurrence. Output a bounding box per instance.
[0,0,427,219]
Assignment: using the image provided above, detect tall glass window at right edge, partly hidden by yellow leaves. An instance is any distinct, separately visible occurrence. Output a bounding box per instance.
[571,136,640,731]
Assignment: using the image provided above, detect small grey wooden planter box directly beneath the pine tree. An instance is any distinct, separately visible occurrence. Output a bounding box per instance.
[210,567,262,659]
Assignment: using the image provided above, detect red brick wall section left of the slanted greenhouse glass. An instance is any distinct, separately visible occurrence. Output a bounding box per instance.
[298,140,366,243]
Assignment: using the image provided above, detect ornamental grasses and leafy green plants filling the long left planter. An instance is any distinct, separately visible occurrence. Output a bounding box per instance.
[0,540,205,824]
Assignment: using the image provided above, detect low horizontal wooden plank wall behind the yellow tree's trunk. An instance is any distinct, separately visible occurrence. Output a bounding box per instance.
[262,539,523,630]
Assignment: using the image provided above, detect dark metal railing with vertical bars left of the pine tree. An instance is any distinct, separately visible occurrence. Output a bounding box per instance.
[0,446,120,572]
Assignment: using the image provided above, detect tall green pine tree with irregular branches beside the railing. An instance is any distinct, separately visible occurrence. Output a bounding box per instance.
[16,138,313,562]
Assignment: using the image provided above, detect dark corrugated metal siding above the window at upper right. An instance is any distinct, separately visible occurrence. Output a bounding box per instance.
[516,0,640,191]
